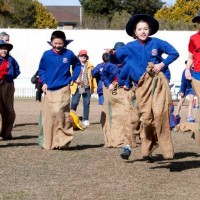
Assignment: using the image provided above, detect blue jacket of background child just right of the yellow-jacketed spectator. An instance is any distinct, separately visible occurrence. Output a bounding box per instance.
[91,62,106,94]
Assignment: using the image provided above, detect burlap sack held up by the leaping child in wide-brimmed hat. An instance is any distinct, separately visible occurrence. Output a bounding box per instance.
[136,63,174,159]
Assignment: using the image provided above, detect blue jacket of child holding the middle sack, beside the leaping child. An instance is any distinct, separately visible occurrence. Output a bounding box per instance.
[102,62,124,87]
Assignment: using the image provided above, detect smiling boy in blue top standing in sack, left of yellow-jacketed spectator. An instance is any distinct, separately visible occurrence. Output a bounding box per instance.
[38,31,81,150]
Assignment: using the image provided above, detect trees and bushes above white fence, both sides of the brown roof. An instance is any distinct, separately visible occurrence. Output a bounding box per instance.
[0,0,200,30]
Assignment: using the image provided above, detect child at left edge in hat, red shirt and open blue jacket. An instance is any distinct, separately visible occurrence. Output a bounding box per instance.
[0,40,20,140]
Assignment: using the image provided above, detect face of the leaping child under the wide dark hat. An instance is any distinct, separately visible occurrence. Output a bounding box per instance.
[134,21,150,41]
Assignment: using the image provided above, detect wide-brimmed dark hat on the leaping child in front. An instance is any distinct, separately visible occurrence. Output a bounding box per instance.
[126,14,159,37]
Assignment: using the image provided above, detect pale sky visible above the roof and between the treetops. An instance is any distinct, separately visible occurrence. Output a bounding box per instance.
[39,0,176,6]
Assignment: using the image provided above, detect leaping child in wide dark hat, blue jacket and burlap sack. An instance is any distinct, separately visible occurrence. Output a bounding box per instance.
[108,14,179,160]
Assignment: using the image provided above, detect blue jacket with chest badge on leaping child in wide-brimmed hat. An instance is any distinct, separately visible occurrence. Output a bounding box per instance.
[115,37,179,83]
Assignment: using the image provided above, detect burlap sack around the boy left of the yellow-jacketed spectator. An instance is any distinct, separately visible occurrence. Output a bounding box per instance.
[40,86,74,150]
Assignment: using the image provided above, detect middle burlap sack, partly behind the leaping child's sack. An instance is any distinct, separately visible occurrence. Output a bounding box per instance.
[101,87,138,147]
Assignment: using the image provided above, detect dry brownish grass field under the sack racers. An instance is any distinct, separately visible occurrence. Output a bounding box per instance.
[0,99,200,200]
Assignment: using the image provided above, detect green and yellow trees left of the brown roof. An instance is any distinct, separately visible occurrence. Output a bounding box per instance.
[0,0,58,29]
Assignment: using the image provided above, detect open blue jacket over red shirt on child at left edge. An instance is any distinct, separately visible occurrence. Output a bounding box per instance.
[0,55,20,83]
